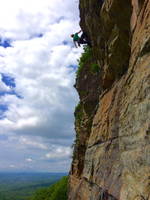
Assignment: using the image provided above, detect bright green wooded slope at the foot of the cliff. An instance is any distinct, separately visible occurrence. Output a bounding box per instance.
[30,176,68,200]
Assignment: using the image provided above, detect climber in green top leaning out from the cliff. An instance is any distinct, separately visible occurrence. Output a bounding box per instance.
[71,30,91,48]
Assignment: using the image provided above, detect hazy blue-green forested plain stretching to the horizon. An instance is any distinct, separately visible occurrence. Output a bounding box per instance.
[0,173,65,200]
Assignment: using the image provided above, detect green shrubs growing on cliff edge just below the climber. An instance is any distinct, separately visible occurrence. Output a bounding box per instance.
[76,46,92,77]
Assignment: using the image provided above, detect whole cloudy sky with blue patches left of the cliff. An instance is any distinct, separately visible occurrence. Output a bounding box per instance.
[0,0,82,172]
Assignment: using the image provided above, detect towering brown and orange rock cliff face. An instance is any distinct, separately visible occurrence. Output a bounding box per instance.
[68,0,150,200]
